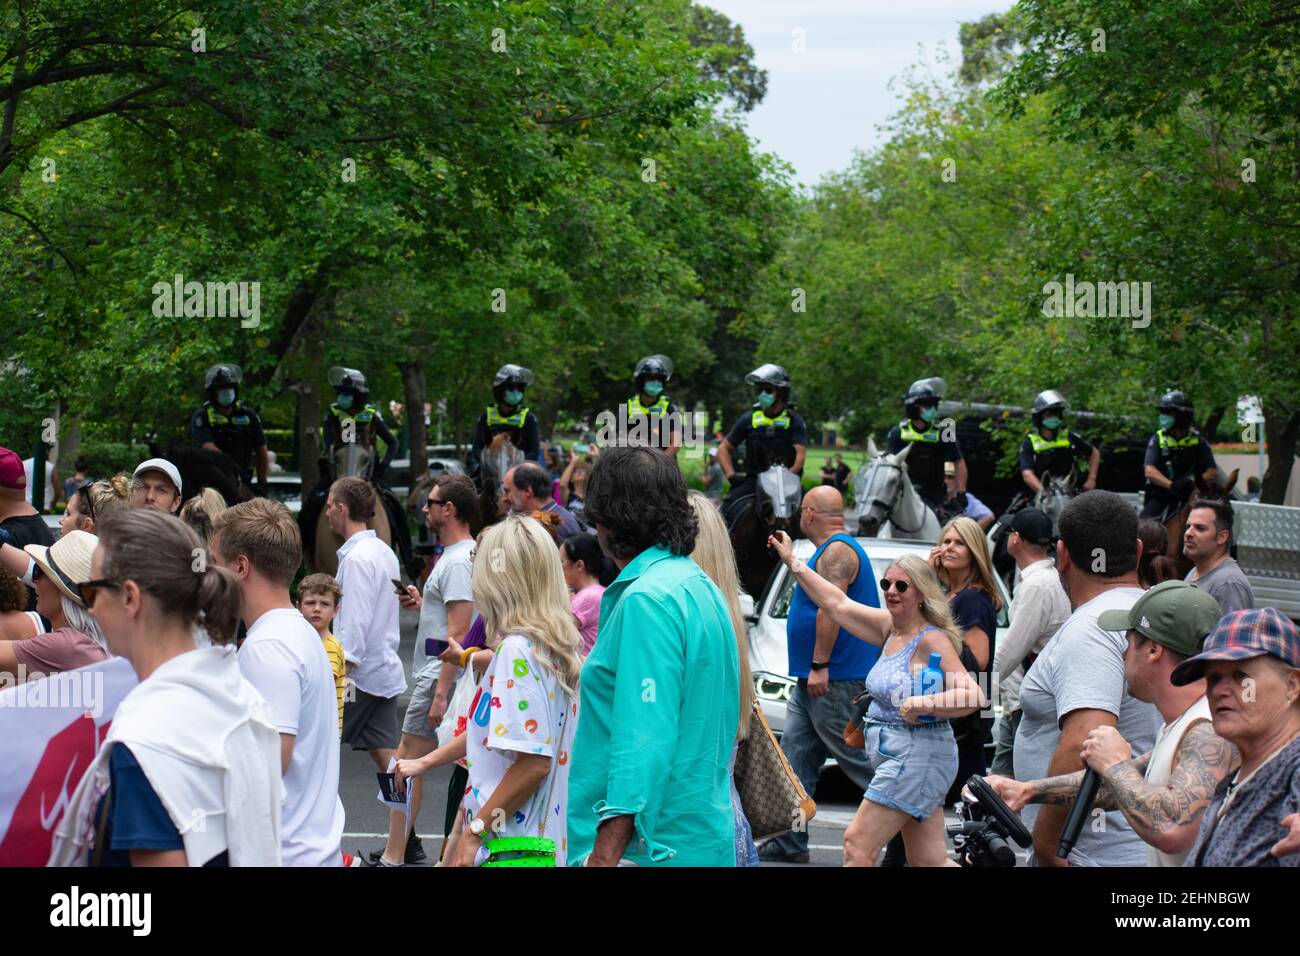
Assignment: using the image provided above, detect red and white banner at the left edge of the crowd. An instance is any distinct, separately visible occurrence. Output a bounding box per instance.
[0,657,137,866]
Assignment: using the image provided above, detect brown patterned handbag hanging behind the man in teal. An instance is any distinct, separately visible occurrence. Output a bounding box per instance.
[735,700,816,840]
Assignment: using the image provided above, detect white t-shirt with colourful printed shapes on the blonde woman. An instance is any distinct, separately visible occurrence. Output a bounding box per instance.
[464,635,577,866]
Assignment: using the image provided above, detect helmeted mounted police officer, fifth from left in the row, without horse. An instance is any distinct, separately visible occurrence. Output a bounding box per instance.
[718,364,809,510]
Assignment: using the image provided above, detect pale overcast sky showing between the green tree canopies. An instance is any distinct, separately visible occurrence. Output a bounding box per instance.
[699,0,1011,186]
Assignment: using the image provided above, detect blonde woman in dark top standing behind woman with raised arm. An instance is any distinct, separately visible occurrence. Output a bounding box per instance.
[930,518,1002,803]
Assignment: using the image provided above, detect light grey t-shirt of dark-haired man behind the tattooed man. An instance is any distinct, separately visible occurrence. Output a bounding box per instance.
[1013,588,1161,866]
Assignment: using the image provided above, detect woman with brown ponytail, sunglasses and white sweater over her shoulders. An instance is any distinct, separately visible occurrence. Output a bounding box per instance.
[49,509,282,866]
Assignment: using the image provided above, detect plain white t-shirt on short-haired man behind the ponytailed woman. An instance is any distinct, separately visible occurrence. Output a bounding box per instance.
[239,607,343,866]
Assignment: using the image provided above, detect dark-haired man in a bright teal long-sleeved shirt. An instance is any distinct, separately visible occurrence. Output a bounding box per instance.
[568,447,740,866]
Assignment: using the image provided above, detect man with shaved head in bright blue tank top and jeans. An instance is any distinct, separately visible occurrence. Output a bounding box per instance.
[758,485,880,862]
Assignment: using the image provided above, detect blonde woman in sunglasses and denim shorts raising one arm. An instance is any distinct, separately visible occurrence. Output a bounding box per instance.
[768,532,985,866]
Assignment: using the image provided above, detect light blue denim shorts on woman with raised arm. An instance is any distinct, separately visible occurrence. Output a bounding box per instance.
[863,721,957,821]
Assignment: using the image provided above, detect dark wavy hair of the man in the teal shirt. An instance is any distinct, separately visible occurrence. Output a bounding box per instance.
[584,446,699,561]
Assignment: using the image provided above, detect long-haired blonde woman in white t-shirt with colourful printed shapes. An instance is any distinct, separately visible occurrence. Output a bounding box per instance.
[394,515,582,866]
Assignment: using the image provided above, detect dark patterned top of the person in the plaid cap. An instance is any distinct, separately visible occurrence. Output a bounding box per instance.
[1183,737,1300,868]
